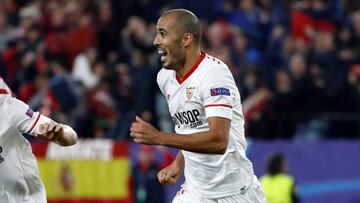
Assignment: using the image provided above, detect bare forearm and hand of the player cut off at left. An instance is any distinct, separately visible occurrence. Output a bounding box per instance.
[36,121,77,146]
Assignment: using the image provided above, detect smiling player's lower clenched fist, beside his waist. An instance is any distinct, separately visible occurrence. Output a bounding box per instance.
[157,162,181,186]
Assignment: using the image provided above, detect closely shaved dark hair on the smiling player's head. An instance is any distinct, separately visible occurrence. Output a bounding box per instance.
[161,9,202,44]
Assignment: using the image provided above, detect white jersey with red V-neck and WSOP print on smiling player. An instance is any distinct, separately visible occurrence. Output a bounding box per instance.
[157,53,254,198]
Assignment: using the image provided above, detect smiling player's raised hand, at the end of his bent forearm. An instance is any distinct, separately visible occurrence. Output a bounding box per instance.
[130,116,160,144]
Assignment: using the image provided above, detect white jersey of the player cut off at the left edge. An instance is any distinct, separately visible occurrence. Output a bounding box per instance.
[0,78,50,203]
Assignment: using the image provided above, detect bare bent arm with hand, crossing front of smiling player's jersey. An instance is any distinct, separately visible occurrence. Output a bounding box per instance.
[130,117,231,154]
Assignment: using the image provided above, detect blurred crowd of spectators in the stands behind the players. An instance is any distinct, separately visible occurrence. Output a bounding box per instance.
[0,0,360,140]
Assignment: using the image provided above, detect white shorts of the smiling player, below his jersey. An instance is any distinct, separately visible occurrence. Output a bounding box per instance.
[172,176,266,203]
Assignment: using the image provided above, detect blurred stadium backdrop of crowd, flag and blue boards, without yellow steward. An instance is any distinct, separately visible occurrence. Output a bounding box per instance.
[0,0,360,203]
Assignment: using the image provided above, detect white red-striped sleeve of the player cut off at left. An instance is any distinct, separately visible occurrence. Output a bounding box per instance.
[6,97,51,135]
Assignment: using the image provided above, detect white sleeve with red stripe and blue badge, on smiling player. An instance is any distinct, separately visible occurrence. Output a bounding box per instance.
[201,66,236,120]
